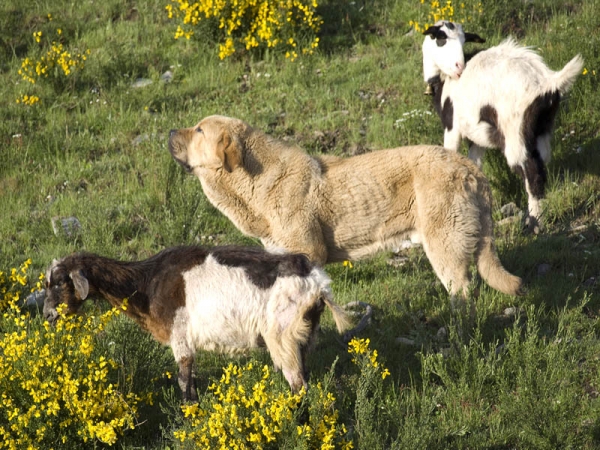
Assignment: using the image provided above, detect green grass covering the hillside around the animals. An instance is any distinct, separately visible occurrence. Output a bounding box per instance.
[0,0,600,449]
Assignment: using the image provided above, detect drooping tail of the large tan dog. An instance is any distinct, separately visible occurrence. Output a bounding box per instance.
[476,186,523,295]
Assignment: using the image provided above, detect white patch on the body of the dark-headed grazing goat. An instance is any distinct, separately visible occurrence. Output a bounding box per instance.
[171,256,331,380]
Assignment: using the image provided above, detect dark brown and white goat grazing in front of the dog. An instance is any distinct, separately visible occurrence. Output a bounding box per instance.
[44,246,347,400]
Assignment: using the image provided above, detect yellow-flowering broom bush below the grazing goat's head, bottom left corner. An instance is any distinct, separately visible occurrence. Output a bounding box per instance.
[0,260,152,449]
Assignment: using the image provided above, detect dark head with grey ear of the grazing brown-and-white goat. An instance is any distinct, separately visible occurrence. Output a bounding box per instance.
[43,260,90,322]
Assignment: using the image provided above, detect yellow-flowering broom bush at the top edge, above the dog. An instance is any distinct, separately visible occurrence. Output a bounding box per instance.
[166,0,323,61]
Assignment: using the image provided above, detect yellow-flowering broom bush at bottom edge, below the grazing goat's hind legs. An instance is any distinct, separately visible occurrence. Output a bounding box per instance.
[174,362,352,450]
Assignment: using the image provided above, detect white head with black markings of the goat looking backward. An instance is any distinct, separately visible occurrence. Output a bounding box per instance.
[423,20,485,82]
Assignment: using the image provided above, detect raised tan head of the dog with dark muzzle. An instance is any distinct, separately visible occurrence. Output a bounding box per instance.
[169,116,245,172]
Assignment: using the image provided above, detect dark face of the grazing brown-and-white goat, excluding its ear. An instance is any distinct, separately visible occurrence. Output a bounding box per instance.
[43,264,83,323]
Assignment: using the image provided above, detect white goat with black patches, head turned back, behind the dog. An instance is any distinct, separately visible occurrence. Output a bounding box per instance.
[423,21,583,233]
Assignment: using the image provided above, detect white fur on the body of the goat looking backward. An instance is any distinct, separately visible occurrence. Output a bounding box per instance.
[442,39,571,167]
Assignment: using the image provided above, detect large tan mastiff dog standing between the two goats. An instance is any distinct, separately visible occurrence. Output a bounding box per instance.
[169,116,522,295]
